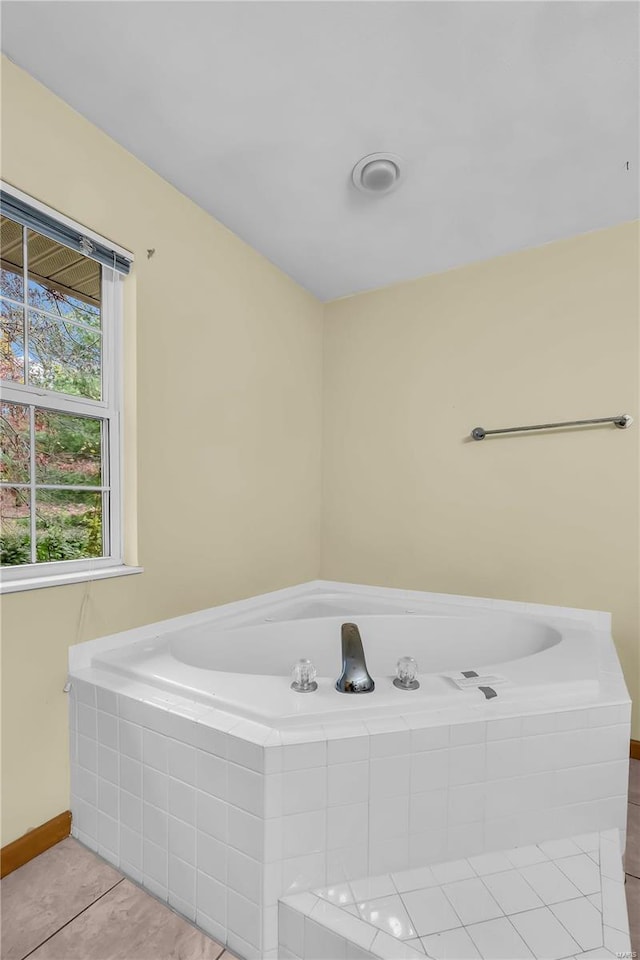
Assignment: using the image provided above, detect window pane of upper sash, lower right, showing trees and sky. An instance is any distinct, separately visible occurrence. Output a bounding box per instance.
[29,310,102,400]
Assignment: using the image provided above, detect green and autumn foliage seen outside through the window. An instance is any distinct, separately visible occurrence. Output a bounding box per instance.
[0,219,106,566]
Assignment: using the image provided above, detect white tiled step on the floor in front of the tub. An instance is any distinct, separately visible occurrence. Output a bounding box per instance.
[279,830,631,960]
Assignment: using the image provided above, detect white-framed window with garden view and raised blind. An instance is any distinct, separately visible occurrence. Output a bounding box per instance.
[0,187,135,590]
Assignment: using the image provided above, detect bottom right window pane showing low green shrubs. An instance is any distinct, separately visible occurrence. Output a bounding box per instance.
[36,490,104,563]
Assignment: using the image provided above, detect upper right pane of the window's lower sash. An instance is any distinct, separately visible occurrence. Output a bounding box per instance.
[35,409,102,487]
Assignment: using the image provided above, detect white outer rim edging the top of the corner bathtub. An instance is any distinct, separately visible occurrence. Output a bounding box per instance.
[69,580,631,750]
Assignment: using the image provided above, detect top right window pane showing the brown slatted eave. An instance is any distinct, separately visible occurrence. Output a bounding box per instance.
[27,230,101,327]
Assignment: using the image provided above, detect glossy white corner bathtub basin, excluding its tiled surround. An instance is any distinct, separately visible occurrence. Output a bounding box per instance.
[86,587,597,726]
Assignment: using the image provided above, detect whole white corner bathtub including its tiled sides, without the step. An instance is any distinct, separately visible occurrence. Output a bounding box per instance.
[69,582,630,960]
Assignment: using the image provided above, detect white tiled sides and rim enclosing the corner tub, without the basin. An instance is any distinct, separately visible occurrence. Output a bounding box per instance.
[70,585,630,960]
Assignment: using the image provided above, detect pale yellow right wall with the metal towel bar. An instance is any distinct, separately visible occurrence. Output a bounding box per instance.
[321,224,640,737]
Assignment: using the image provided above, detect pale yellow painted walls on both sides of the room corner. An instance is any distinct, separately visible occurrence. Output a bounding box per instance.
[1,60,640,843]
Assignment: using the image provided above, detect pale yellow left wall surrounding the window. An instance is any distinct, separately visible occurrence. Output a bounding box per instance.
[1,60,322,843]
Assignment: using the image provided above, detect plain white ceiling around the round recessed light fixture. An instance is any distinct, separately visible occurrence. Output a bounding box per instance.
[2,0,639,300]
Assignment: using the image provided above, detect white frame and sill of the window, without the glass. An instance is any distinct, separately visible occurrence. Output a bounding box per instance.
[0,184,141,593]
